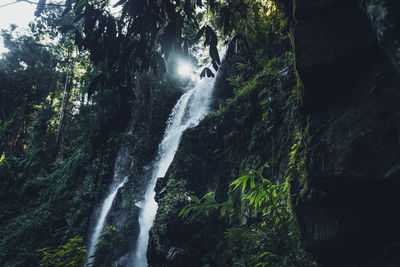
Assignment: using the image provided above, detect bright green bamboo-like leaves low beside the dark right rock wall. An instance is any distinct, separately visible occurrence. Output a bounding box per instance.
[179,164,297,267]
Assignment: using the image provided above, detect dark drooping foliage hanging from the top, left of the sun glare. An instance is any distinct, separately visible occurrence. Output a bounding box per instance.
[58,0,216,95]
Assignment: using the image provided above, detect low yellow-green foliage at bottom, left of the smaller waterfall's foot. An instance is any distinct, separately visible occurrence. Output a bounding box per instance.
[37,236,87,267]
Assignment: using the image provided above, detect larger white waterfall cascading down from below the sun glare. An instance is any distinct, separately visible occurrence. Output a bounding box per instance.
[131,49,223,267]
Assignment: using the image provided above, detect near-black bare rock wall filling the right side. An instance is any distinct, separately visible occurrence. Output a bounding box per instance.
[295,0,400,266]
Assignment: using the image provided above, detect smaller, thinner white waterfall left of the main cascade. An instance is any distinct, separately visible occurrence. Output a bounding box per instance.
[87,148,133,266]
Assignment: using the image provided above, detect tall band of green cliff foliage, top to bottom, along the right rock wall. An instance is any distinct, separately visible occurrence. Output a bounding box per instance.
[180,6,304,266]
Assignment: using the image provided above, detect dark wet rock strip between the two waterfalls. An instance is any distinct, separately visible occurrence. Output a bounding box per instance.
[90,75,182,266]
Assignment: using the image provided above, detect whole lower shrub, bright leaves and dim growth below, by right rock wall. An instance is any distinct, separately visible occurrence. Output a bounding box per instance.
[179,164,315,266]
